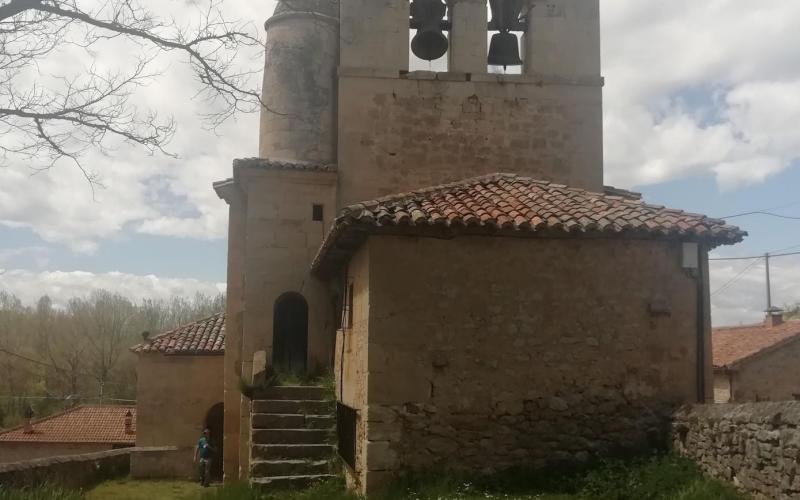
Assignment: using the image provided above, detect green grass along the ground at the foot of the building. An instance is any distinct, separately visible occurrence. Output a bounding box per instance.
[0,455,749,500]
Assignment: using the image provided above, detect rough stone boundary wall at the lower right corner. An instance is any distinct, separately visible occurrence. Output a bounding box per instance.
[672,401,800,500]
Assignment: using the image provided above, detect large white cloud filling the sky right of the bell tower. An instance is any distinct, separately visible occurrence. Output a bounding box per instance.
[602,0,800,189]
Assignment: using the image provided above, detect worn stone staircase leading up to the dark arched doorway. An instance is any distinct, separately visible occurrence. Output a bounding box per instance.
[250,386,336,488]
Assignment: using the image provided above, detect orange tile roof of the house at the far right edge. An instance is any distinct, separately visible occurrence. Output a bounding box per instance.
[711,320,800,368]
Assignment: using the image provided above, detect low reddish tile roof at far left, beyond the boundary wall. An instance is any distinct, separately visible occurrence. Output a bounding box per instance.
[0,406,136,445]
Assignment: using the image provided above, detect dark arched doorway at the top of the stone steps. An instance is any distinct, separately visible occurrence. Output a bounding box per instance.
[272,293,308,373]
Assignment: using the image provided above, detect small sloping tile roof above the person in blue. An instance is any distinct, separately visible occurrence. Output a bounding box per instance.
[131,313,225,355]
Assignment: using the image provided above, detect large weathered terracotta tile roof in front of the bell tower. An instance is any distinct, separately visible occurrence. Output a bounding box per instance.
[312,174,747,274]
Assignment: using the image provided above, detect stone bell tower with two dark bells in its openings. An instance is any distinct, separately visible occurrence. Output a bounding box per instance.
[338,0,603,206]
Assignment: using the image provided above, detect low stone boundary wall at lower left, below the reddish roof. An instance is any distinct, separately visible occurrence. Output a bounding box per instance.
[0,448,178,489]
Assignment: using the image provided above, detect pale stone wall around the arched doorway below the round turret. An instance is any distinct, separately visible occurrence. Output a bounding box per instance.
[238,167,336,478]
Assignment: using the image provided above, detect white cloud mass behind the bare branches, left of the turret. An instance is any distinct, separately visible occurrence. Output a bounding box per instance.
[0,0,273,254]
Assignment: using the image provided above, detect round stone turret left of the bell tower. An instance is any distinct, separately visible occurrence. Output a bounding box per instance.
[259,0,339,163]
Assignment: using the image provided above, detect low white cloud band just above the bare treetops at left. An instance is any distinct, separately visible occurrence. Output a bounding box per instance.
[0,270,225,306]
